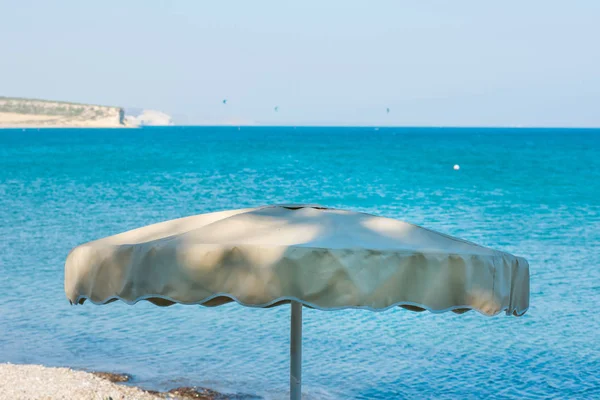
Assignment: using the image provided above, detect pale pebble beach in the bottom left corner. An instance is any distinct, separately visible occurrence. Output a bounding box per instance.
[0,363,234,400]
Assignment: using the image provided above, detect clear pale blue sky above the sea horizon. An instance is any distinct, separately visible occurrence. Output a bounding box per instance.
[0,0,600,127]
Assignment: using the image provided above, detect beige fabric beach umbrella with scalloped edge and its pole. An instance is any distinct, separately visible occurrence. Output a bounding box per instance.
[65,205,529,399]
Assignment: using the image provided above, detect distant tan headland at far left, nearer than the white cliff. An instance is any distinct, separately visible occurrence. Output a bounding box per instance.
[0,97,128,127]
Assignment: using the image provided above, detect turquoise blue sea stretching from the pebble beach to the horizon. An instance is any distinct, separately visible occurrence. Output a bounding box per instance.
[0,127,600,399]
